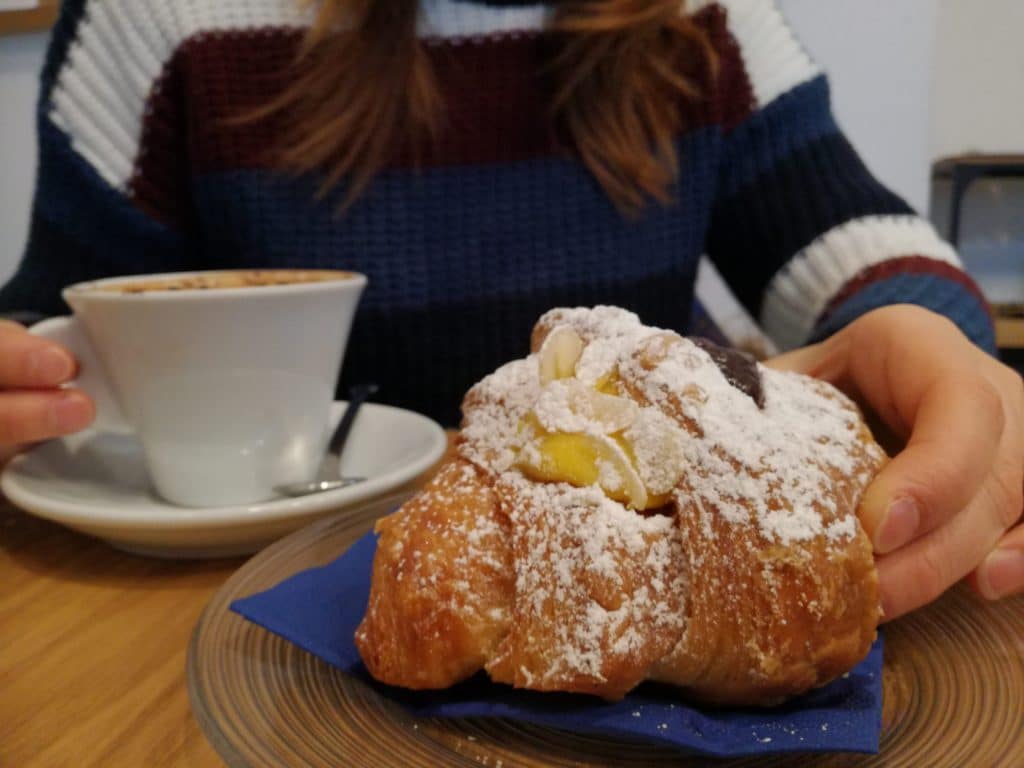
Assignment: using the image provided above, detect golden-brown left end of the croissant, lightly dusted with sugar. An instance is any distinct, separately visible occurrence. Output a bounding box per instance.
[355,459,514,689]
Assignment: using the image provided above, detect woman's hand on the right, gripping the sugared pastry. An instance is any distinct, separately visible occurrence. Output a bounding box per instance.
[767,305,1024,620]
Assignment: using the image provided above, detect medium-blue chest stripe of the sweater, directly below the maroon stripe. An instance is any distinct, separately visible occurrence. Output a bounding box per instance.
[194,130,721,307]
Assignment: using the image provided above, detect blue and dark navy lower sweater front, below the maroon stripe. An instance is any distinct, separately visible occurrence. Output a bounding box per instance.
[195,138,721,424]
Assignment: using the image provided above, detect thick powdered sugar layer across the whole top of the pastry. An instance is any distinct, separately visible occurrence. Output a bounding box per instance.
[463,307,878,544]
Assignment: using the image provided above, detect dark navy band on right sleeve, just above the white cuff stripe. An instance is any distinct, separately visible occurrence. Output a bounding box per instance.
[708,134,912,316]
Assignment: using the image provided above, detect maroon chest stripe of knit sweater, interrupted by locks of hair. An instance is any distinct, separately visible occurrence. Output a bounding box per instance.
[130,5,754,222]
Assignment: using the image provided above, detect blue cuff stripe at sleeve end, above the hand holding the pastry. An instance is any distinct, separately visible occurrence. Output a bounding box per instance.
[810,274,995,354]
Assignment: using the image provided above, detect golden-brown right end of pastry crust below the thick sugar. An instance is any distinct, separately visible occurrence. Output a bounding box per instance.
[650,456,880,705]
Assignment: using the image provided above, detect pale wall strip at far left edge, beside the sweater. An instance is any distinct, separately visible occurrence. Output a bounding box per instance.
[0,30,46,283]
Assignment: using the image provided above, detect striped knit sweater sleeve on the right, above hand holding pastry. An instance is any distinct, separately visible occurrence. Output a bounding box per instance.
[707,0,995,351]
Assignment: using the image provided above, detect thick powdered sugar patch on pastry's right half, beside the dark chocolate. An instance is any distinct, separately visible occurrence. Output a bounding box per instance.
[620,337,881,544]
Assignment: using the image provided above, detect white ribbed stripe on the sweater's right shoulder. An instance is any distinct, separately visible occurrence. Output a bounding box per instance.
[687,0,821,109]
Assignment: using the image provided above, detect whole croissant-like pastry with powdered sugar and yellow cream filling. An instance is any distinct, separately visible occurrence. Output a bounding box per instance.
[355,307,885,705]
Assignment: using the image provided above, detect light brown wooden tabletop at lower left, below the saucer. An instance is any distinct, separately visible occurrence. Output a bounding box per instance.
[0,503,245,768]
